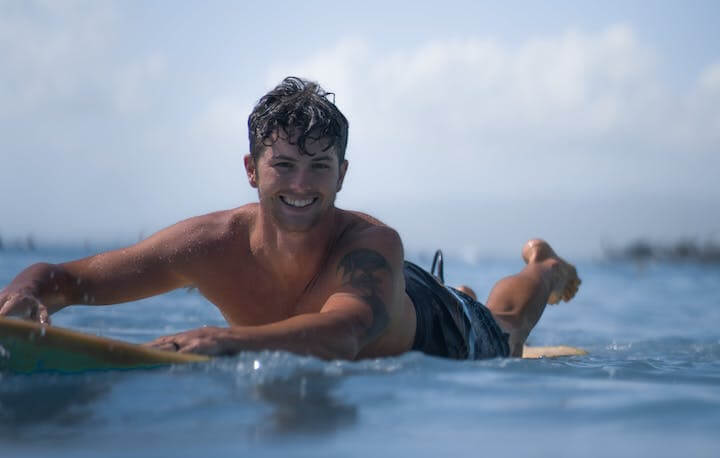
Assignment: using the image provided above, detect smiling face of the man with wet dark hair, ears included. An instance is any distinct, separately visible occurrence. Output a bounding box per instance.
[245,132,347,232]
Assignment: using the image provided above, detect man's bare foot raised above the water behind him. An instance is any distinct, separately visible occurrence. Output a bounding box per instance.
[522,239,582,304]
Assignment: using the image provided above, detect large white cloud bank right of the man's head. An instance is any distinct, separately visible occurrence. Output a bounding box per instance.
[268,24,720,253]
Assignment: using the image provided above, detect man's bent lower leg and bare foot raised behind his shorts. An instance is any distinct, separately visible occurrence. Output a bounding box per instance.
[486,239,580,357]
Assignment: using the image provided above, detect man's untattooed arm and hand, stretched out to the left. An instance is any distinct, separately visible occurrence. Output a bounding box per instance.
[0,217,212,323]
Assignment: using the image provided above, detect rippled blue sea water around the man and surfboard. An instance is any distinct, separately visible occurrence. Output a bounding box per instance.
[0,249,720,457]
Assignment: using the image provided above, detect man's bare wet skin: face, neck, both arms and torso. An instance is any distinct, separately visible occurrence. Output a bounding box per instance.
[0,136,415,359]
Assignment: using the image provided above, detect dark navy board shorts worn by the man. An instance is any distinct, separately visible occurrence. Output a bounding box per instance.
[404,261,510,359]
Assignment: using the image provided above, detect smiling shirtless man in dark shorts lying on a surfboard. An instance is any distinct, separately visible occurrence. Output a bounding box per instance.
[0,77,580,359]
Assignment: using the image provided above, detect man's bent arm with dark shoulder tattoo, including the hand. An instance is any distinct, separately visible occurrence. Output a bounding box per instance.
[147,228,404,360]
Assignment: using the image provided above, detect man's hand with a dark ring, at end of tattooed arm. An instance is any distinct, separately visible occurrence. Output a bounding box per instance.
[143,326,233,356]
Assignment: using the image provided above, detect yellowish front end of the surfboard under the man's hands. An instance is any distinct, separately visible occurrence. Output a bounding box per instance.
[0,317,209,374]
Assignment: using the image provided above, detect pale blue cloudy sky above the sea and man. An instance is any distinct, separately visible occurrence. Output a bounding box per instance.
[0,0,720,260]
